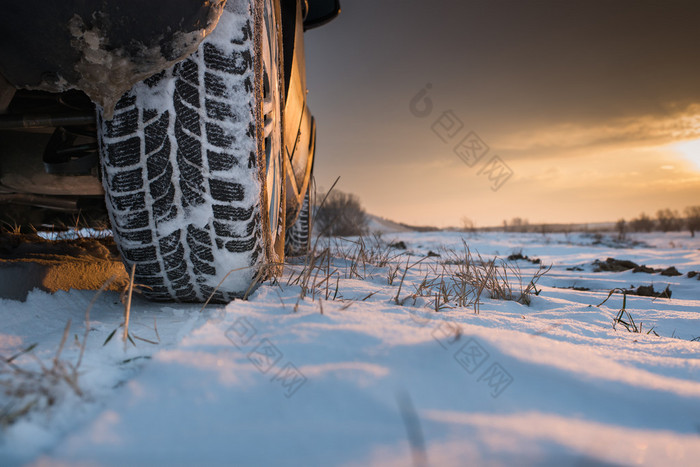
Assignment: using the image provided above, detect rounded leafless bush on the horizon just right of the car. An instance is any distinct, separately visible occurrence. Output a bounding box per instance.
[314,191,368,236]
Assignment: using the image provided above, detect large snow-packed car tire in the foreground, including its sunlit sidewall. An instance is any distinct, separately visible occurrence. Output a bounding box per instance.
[98,0,285,302]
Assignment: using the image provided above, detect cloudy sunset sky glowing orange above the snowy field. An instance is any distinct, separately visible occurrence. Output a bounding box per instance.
[305,0,700,227]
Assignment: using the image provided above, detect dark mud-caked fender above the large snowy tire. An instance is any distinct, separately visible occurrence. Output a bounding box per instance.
[0,0,225,118]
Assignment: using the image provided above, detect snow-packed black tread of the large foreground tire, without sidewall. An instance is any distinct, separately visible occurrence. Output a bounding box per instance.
[98,3,264,302]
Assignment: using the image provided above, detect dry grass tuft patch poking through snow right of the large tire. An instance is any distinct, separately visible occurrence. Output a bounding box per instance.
[278,235,551,313]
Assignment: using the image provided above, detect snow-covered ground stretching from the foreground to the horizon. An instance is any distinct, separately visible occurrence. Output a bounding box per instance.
[0,232,700,466]
